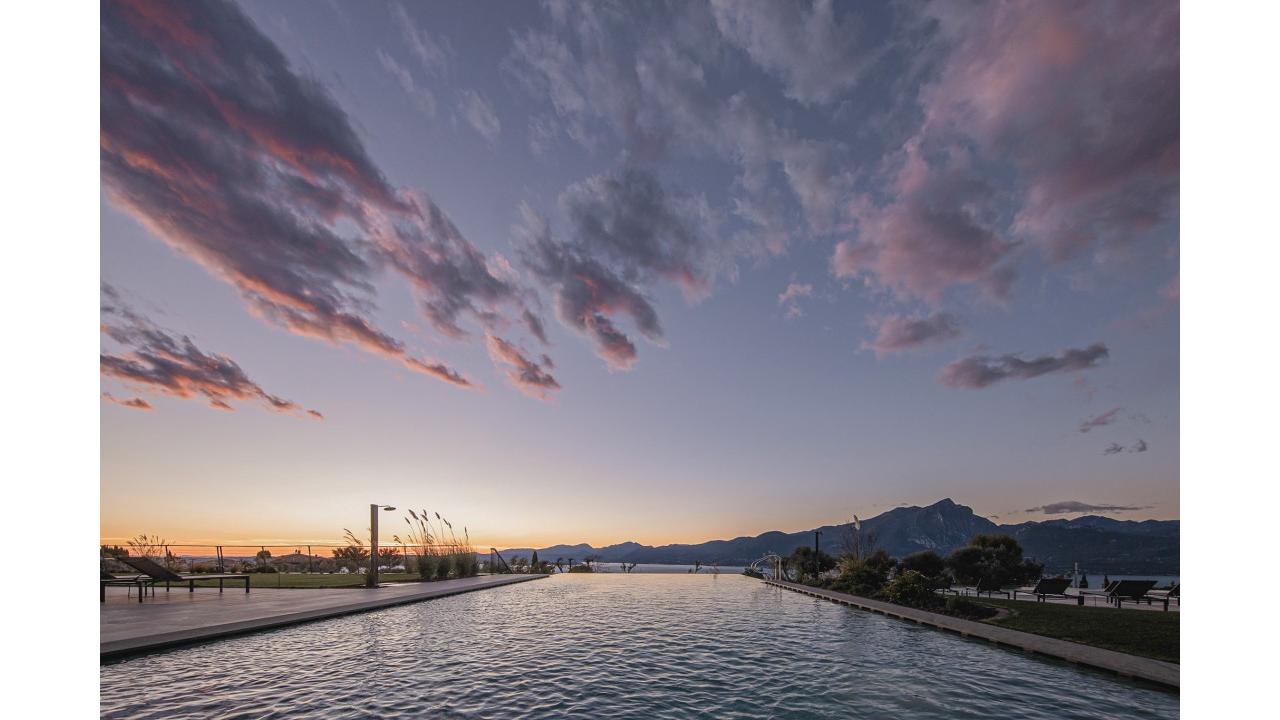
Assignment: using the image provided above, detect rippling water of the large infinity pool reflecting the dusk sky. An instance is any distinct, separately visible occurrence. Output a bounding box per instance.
[101,574,1178,720]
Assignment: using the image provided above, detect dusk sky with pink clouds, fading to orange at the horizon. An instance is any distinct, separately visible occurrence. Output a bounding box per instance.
[100,0,1179,547]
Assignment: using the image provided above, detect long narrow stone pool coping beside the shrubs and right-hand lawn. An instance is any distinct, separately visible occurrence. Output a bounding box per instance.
[764,580,1180,689]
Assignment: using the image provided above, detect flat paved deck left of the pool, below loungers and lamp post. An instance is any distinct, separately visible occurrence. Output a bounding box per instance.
[99,575,547,660]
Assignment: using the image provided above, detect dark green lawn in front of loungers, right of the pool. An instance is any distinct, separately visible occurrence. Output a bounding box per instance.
[982,600,1181,662]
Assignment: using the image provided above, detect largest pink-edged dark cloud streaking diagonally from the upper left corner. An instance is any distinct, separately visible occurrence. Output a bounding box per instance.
[100,0,545,387]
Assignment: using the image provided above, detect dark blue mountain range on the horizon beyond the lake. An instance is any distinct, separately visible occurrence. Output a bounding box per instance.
[502,498,1179,575]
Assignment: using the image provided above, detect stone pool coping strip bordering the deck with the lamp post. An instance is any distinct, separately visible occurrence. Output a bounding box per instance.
[99,574,548,661]
